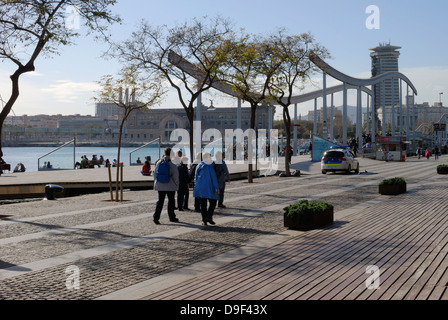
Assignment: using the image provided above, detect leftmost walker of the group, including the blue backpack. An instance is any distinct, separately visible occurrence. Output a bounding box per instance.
[153,148,179,224]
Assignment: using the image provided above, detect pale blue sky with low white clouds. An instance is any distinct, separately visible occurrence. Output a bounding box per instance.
[0,0,448,120]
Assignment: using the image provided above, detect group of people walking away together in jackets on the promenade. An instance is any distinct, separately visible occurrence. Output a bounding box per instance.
[153,148,230,226]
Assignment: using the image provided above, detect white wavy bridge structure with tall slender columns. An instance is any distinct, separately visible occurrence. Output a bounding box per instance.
[168,47,424,156]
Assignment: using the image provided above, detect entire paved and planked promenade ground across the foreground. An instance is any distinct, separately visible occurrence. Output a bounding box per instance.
[0,156,448,304]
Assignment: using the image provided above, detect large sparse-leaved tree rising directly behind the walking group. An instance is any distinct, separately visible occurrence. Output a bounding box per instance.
[112,17,232,159]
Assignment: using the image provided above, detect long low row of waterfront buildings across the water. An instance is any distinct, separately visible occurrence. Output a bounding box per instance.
[2,103,274,144]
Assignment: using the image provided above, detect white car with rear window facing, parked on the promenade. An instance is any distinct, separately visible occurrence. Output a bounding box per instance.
[321,147,359,174]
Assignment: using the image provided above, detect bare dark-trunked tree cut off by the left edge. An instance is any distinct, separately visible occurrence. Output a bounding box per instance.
[0,0,120,157]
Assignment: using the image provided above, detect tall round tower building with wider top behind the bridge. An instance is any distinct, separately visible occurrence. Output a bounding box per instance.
[369,43,401,109]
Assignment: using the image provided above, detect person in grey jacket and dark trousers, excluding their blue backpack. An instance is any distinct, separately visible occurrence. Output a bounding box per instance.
[153,148,179,224]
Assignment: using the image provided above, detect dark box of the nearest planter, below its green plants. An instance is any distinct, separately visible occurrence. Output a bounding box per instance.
[283,209,334,231]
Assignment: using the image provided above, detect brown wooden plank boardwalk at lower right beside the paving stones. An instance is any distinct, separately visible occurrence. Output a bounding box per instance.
[145,177,448,300]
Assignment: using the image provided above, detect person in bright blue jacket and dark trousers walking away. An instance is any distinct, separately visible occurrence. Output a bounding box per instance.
[193,152,219,226]
